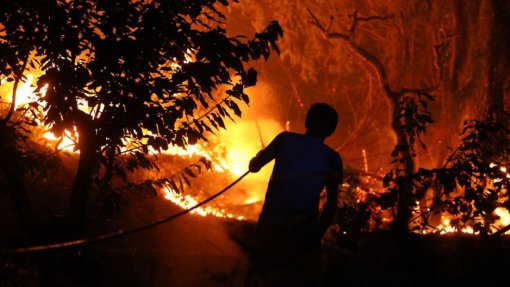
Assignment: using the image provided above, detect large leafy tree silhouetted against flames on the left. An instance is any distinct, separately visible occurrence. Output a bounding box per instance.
[0,0,282,241]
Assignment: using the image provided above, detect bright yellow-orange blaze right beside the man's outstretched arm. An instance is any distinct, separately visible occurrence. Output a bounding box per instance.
[155,119,282,220]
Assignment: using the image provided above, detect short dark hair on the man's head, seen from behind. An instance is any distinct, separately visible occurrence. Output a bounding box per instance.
[305,103,338,137]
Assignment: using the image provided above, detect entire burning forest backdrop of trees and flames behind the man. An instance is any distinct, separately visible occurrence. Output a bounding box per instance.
[0,0,510,286]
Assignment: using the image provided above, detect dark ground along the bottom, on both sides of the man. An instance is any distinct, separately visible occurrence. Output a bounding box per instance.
[0,194,510,287]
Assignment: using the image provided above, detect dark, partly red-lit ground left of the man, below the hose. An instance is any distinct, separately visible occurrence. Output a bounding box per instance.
[0,190,251,287]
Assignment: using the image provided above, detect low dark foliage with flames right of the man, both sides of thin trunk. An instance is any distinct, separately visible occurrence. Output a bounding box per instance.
[337,111,510,238]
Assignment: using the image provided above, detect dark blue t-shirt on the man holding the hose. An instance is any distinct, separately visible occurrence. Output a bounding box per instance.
[256,132,343,228]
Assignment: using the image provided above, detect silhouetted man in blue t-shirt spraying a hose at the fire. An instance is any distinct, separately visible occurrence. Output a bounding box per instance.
[246,103,343,287]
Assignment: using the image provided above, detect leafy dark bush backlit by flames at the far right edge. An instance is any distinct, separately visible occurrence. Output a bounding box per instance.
[412,112,510,236]
